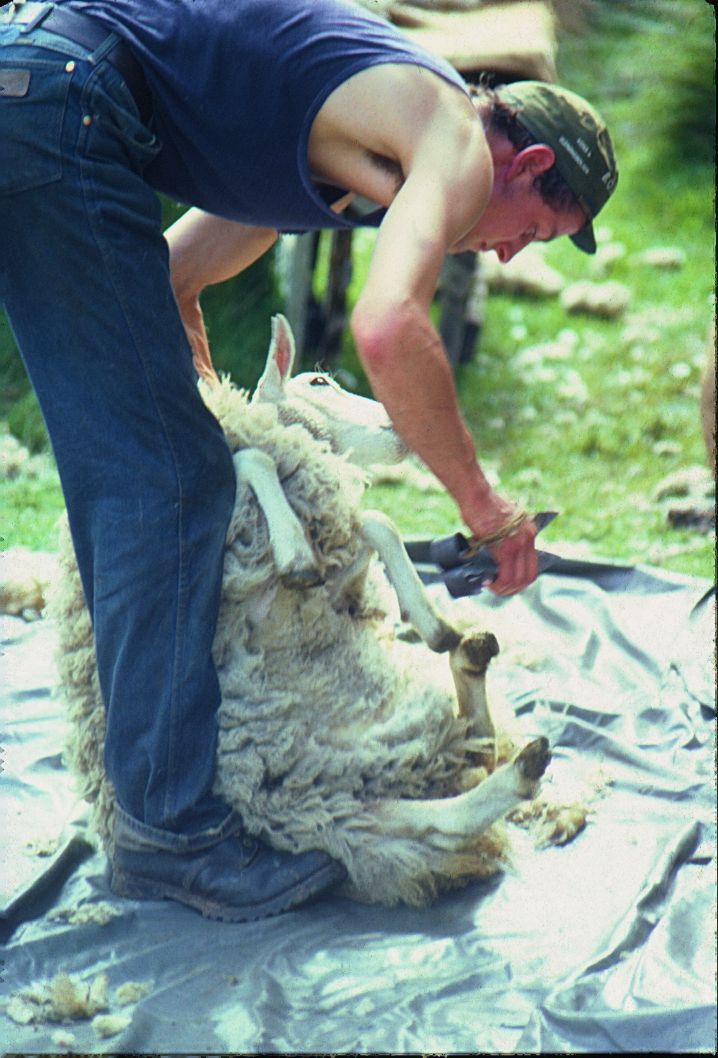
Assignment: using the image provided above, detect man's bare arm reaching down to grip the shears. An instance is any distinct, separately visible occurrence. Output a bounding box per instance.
[352,92,537,595]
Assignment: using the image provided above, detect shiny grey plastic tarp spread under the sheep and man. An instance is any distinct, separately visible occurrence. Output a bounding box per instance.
[0,562,716,1054]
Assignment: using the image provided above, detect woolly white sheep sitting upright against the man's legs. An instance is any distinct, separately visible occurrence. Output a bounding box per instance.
[51,316,551,906]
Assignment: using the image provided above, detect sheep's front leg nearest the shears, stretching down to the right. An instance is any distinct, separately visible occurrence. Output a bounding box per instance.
[362,511,461,654]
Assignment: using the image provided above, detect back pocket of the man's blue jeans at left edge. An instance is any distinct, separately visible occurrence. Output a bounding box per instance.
[0,52,72,194]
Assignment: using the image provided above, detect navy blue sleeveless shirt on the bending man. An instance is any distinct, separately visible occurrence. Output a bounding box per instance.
[60,0,465,231]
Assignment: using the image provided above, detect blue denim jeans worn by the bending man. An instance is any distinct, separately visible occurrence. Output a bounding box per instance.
[0,18,235,847]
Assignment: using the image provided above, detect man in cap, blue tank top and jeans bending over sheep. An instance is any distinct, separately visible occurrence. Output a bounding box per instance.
[0,0,615,920]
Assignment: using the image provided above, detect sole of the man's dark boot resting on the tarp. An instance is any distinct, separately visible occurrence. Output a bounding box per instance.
[110,863,346,923]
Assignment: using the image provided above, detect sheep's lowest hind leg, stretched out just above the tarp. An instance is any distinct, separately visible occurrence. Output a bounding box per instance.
[374,737,551,851]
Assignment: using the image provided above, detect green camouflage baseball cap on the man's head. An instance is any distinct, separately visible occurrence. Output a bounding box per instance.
[498,80,619,254]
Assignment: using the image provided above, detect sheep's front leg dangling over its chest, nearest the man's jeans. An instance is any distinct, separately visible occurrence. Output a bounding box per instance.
[233,449,321,587]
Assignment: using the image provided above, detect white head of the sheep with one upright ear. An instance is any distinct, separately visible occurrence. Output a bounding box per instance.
[252,315,407,467]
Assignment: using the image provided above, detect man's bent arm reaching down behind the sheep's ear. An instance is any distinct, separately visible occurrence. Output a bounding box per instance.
[165,209,277,384]
